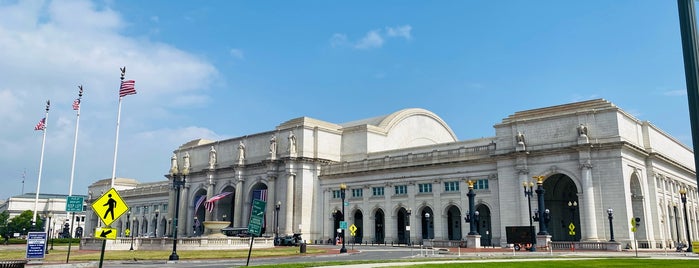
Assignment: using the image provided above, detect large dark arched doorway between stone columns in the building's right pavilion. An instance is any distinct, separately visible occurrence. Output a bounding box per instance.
[537,173,582,241]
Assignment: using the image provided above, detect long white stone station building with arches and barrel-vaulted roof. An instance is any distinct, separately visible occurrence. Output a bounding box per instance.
[86,99,699,248]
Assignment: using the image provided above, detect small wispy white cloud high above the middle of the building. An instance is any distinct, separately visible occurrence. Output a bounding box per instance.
[330,25,412,50]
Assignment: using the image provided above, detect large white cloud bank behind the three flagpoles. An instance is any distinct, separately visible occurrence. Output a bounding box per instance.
[0,0,218,198]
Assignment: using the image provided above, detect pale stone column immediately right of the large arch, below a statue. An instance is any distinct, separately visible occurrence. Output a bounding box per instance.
[580,163,599,241]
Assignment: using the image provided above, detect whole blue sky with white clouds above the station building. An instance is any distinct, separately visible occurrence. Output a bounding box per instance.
[0,0,691,199]
